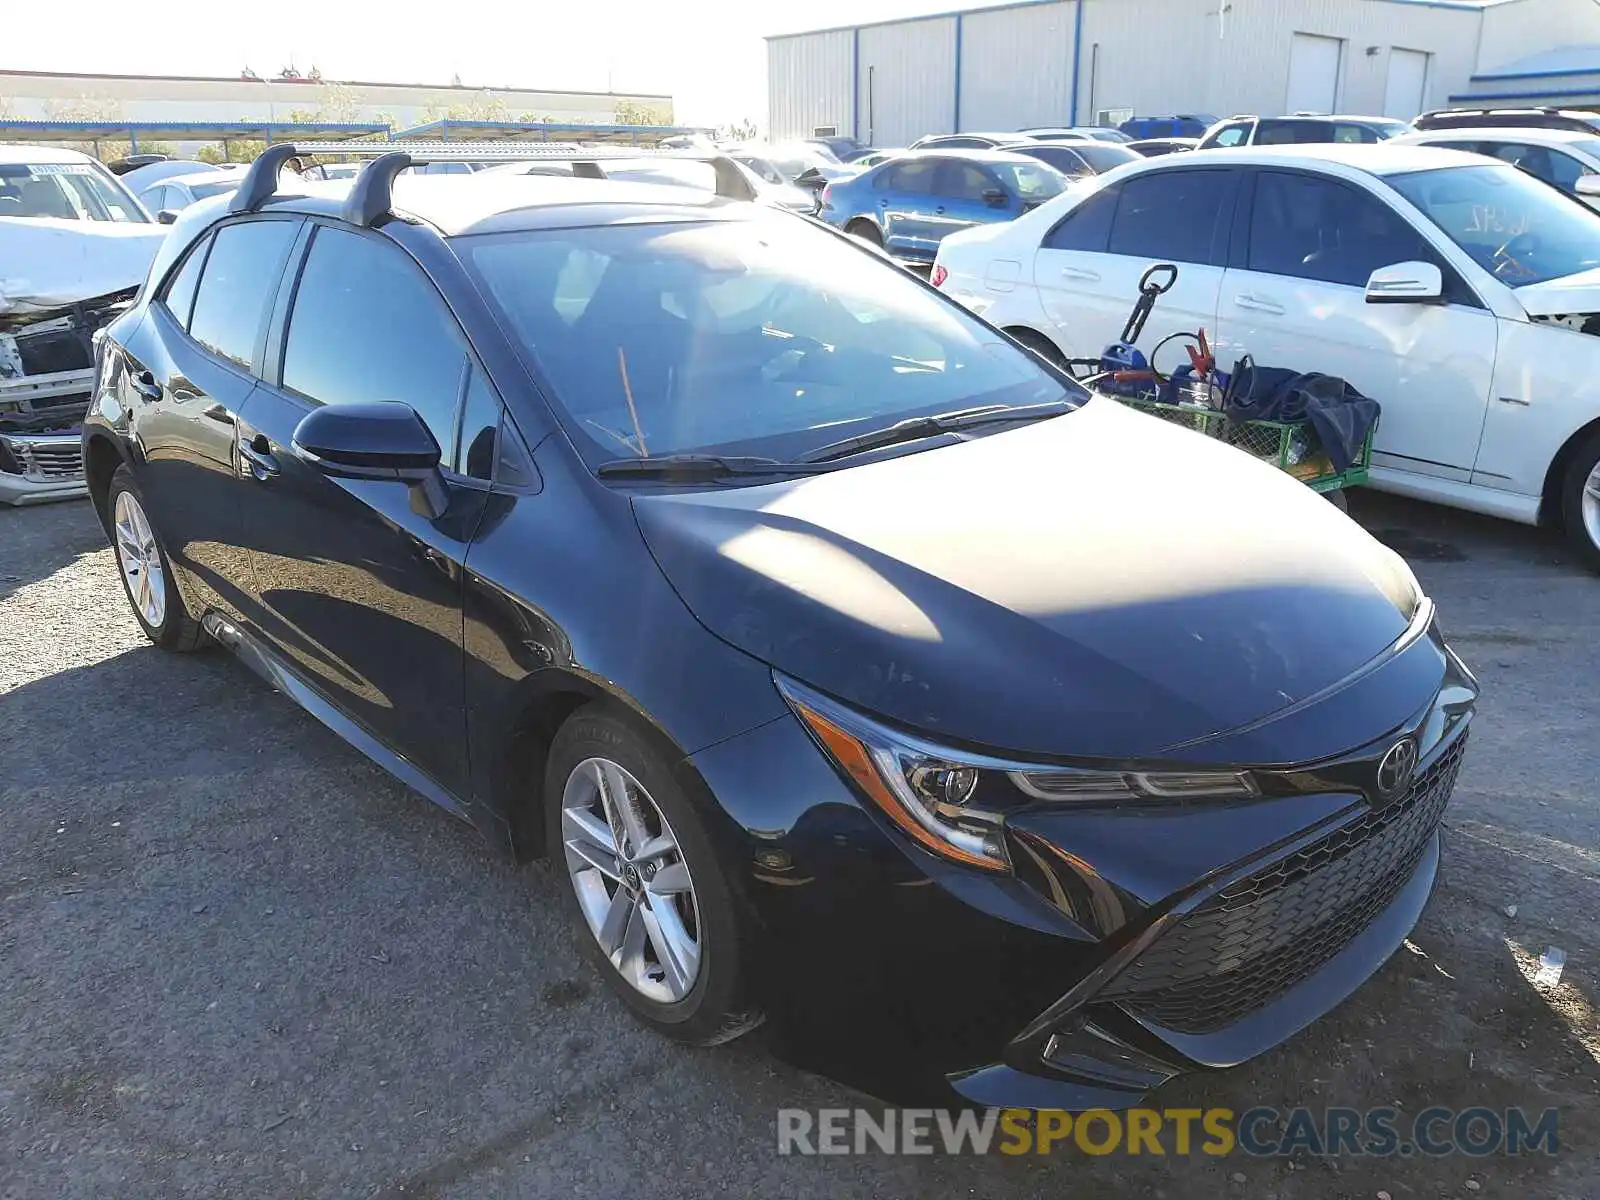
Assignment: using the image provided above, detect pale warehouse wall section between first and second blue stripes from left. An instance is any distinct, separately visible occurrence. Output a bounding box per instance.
[856,16,955,146]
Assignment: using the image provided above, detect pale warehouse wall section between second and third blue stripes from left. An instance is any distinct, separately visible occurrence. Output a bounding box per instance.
[957,0,1077,130]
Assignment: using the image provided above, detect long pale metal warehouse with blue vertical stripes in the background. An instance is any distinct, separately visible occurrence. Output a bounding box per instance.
[766,0,1600,146]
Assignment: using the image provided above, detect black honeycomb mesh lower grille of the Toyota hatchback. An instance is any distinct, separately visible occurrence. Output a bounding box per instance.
[1106,734,1467,1034]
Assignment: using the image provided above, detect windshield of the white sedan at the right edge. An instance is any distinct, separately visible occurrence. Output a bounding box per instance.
[1386,165,1600,288]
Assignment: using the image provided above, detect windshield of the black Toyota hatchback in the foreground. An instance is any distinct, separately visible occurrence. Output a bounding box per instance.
[456,213,1082,466]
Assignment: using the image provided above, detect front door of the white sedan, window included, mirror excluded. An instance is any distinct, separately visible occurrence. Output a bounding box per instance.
[1214,170,1499,482]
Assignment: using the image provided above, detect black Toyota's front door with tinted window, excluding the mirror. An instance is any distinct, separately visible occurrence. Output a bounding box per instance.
[228,224,486,795]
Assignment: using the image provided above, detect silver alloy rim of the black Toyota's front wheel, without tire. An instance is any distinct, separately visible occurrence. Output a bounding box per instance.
[562,758,701,1003]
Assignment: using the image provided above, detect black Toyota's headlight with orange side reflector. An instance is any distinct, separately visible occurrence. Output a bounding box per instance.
[773,674,1261,870]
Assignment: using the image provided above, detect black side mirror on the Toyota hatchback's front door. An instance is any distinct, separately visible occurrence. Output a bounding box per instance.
[294,400,450,518]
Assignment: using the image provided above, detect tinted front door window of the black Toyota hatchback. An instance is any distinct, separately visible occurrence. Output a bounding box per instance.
[283,227,467,462]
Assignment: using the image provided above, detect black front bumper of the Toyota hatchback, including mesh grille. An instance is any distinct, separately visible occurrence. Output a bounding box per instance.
[691,637,1477,1110]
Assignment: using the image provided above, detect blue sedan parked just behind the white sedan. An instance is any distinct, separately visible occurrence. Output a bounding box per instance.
[818,150,1067,262]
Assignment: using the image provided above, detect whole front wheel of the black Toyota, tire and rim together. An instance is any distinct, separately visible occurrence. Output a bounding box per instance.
[544,704,763,1046]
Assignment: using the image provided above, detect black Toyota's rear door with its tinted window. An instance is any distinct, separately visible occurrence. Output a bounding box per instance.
[125,218,301,616]
